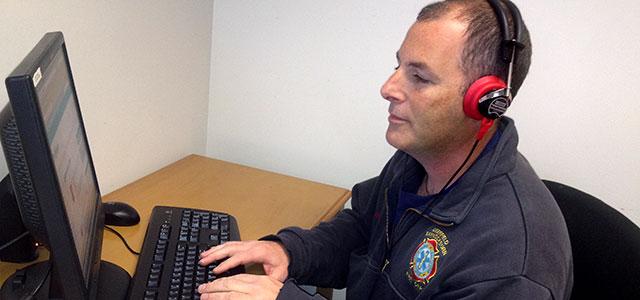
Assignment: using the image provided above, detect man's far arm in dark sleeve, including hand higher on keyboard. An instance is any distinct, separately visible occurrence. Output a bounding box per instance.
[199,178,376,296]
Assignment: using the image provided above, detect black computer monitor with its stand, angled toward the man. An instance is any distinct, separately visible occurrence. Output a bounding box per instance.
[0,32,129,299]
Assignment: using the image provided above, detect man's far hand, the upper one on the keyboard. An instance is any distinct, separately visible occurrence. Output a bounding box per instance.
[199,241,289,282]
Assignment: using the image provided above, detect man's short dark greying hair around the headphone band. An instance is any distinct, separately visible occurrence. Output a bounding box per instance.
[417,0,531,96]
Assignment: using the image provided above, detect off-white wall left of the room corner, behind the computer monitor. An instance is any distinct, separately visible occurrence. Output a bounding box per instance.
[0,0,213,193]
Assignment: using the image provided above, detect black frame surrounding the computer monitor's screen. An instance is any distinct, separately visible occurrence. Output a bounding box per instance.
[5,32,104,299]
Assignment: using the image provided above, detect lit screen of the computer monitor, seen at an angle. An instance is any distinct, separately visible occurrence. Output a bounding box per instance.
[35,43,100,286]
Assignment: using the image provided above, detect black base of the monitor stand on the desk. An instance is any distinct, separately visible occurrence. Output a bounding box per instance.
[0,261,131,300]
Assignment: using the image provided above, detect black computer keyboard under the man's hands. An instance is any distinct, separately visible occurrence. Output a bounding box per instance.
[129,206,244,300]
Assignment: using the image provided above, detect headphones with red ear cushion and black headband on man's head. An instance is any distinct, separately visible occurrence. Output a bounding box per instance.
[463,0,524,140]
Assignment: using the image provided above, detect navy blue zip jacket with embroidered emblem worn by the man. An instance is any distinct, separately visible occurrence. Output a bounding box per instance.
[273,118,573,299]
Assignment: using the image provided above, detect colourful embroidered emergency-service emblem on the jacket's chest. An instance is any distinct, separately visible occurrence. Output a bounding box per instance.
[407,228,449,290]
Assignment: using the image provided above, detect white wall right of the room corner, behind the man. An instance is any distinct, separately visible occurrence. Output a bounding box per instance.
[207,0,640,224]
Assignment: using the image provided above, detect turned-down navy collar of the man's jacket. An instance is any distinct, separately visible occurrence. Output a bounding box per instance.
[389,117,518,224]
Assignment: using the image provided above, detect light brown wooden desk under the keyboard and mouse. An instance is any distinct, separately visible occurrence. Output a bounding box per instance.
[0,155,351,282]
